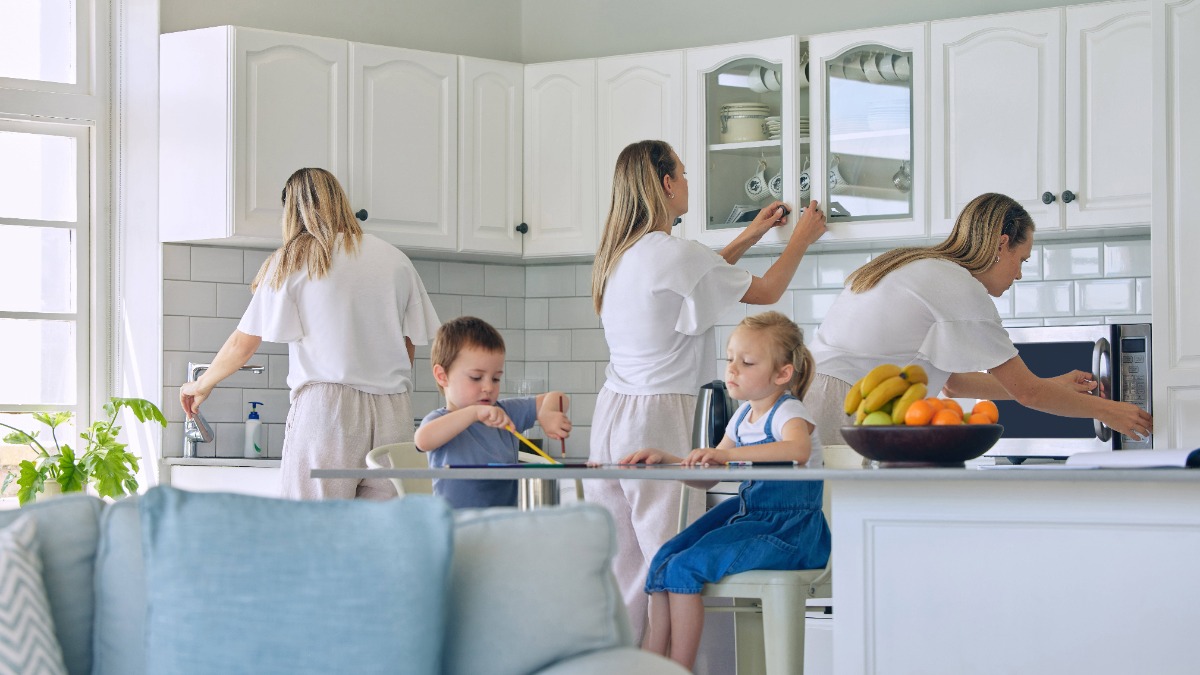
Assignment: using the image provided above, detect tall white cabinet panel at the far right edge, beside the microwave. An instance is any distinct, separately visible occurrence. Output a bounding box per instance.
[1150,0,1200,448]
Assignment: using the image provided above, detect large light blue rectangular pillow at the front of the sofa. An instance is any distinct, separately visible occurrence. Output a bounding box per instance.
[139,488,452,675]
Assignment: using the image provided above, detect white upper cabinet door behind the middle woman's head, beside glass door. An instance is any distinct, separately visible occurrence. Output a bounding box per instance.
[596,52,688,231]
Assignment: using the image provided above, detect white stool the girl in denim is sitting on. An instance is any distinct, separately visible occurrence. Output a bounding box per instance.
[679,485,833,675]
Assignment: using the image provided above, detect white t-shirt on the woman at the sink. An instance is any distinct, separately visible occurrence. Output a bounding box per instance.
[238,234,440,400]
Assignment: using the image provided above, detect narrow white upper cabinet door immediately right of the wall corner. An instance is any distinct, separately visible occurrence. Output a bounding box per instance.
[524,59,602,257]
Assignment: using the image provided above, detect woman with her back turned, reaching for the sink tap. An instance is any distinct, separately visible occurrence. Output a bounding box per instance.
[179,168,439,500]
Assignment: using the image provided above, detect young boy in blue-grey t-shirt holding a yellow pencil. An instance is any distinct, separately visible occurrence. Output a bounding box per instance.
[414,316,571,508]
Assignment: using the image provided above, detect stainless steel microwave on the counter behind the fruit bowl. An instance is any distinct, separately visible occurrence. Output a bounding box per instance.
[988,323,1153,462]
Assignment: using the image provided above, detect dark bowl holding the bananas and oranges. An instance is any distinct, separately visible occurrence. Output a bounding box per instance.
[841,424,1004,466]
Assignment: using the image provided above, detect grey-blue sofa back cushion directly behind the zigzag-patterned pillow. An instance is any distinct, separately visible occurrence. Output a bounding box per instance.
[0,487,103,675]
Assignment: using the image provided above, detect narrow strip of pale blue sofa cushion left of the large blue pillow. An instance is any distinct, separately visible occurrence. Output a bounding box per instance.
[92,497,146,675]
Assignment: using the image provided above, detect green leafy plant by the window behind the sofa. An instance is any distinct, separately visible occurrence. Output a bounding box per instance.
[0,396,167,504]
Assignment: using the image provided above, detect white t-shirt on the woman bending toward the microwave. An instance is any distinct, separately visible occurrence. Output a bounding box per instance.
[810,258,1016,396]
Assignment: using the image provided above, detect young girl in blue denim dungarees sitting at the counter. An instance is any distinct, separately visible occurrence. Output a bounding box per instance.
[622,312,829,668]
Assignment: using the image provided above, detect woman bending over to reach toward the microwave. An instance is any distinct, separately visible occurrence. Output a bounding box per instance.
[804,193,1153,446]
